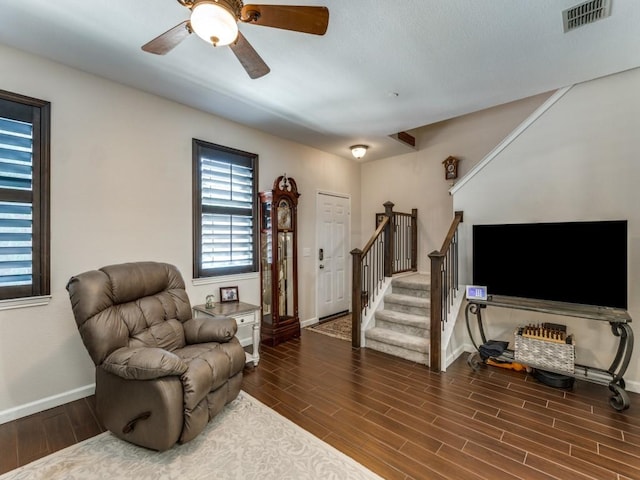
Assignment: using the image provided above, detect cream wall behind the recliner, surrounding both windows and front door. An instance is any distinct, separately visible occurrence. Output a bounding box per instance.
[0,46,360,421]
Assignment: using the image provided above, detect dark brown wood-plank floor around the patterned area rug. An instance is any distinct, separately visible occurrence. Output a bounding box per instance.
[0,331,640,480]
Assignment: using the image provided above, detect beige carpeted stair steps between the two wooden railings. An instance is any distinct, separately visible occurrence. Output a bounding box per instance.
[365,274,430,365]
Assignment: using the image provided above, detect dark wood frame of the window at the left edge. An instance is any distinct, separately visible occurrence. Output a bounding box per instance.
[0,90,51,300]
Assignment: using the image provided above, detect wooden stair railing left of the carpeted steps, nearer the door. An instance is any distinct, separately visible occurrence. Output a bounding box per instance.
[351,202,418,348]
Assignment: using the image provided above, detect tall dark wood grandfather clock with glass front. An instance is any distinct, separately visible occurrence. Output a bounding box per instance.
[260,174,300,346]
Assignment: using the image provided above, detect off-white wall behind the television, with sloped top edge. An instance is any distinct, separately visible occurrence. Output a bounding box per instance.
[453,69,640,391]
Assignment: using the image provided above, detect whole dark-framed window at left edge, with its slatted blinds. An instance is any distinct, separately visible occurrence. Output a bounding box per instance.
[0,91,50,300]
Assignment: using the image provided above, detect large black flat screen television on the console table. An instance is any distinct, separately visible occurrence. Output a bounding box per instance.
[473,220,627,310]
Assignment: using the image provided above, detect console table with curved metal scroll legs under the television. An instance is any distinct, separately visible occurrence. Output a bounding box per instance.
[465,295,633,411]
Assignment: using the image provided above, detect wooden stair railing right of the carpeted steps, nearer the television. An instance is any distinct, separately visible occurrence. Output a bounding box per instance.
[429,212,463,372]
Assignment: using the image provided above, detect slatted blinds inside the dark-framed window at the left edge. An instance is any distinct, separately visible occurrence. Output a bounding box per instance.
[0,118,33,287]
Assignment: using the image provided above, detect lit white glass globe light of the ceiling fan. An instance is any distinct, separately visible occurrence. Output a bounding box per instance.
[191,0,238,47]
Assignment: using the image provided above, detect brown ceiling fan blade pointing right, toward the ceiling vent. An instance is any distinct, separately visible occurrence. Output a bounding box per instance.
[240,5,329,35]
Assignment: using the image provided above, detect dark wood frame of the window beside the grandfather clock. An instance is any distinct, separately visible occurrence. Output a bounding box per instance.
[192,138,259,279]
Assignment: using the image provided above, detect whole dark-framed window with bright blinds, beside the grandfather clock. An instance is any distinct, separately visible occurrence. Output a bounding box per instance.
[193,139,258,278]
